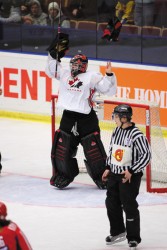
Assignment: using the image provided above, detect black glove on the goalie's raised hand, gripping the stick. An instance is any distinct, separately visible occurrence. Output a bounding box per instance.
[47,33,69,62]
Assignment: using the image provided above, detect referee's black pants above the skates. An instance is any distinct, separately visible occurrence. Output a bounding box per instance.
[106,173,143,243]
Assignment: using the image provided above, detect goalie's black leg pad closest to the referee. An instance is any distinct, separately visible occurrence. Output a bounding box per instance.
[81,132,107,189]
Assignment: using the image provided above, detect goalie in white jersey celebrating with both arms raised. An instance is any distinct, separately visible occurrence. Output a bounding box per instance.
[46,33,117,189]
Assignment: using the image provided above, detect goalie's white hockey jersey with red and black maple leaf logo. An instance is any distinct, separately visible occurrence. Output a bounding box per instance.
[46,55,117,114]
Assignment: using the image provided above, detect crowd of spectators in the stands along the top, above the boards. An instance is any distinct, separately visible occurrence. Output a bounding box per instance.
[0,0,167,28]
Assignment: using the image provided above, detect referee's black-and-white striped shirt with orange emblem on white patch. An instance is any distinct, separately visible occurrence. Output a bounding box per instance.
[106,123,151,174]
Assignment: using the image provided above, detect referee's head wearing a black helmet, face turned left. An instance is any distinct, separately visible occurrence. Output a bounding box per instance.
[112,104,133,127]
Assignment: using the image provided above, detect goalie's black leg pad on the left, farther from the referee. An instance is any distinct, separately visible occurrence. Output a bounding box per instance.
[50,129,79,188]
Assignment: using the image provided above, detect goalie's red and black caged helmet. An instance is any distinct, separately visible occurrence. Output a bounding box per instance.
[70,54,88,77]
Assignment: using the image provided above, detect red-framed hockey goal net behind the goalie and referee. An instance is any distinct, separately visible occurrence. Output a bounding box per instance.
[51,95,167,193]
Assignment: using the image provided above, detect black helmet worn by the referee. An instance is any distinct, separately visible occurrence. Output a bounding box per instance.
[112,104,133,121]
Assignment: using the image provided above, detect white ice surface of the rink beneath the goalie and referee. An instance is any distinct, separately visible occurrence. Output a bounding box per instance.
[0,118,167,250]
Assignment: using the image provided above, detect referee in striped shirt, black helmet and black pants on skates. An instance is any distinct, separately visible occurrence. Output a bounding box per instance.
[102,104,151,249]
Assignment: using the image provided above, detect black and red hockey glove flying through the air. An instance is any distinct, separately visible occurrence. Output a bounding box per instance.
[102,17,122,42]
